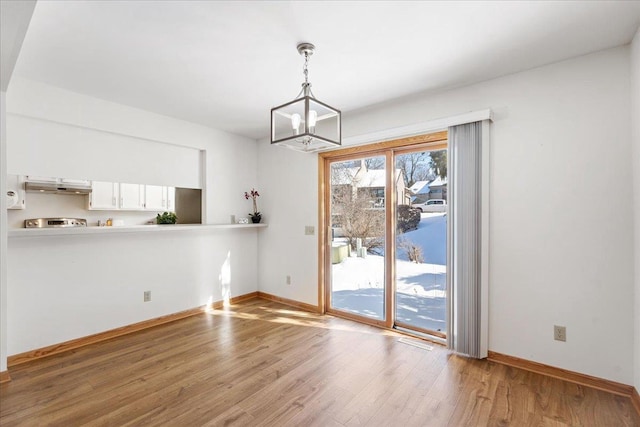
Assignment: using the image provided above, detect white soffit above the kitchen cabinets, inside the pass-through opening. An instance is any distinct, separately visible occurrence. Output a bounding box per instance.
[7,113,202,188]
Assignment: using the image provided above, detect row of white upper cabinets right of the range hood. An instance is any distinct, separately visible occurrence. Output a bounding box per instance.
[89,181,175,212]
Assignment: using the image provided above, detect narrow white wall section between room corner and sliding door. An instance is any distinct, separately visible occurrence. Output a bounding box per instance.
[258,147,318,305]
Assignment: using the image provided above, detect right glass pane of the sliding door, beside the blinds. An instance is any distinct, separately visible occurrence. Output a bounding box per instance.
[395,150,447,337]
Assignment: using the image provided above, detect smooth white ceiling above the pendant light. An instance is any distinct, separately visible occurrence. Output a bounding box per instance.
[8,0,640,139]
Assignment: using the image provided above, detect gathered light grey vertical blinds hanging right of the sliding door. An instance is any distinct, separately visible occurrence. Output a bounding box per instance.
[447,122,489,358]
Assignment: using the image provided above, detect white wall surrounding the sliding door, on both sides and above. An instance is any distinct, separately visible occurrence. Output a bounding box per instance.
[258,47,634,384]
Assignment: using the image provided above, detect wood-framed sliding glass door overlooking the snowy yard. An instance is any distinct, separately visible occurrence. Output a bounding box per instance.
[321,132,447,337]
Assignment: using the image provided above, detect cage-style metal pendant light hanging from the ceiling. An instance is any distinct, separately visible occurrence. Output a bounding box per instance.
[271,43,342,152]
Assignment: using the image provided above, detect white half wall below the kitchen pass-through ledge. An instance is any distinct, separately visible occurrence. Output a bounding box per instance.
[7,229,257,355]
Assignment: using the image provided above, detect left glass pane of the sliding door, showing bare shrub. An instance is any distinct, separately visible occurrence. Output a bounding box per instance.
[329,156,386,321]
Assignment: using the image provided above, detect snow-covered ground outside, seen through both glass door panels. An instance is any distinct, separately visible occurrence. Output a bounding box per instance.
[331,213,447,332]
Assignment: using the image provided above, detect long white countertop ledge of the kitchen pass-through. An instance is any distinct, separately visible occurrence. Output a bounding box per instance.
[7,224,267,237]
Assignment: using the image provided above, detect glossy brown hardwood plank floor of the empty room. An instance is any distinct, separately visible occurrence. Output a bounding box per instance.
[0,299,640,427]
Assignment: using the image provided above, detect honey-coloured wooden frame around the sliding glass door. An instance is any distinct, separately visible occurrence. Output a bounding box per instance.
[318,130,448,329]
